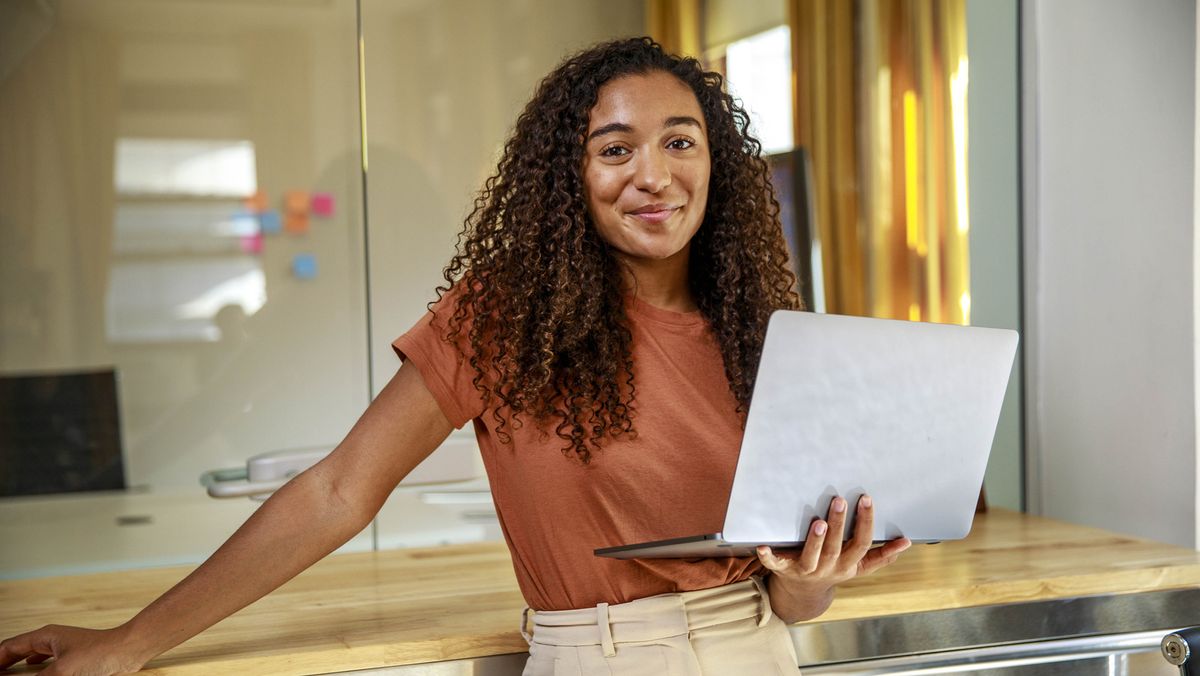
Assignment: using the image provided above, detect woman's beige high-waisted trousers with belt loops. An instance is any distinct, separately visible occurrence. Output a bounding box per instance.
[521,578,800,676]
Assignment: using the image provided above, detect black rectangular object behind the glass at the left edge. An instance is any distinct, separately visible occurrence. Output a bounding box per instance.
[0,370,126,497]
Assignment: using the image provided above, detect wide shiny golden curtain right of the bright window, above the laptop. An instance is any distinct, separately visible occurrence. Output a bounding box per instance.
[790,0,970,324]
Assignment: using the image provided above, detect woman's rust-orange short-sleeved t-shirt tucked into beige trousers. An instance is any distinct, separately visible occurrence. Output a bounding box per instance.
[392,297,762,610]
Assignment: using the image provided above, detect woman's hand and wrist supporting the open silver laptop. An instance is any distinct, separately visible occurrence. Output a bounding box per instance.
[757,495,912,624]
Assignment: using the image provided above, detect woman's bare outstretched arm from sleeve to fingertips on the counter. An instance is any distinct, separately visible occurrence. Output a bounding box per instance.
[0,363,452,676]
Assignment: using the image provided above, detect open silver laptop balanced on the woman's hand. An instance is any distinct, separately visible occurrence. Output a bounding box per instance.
[595,311,1018,558]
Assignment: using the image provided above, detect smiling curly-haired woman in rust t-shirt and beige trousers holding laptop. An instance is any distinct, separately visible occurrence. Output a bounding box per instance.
[0,38,908,675]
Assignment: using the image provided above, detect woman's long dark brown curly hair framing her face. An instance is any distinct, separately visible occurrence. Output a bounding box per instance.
[431,37,800,463]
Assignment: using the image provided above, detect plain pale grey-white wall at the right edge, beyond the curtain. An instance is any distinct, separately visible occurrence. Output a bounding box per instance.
[1022,0,1196,546]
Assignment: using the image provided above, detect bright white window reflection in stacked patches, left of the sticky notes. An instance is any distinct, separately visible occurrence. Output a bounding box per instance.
[106,138,266,342]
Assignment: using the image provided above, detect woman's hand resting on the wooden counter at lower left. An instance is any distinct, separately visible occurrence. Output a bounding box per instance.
[0,624,145,676]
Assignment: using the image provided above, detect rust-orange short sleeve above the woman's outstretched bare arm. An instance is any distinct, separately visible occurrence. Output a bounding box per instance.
[391,294,484,427]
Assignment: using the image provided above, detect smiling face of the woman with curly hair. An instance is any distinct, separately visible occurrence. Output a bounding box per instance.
[583,71,712,270]
